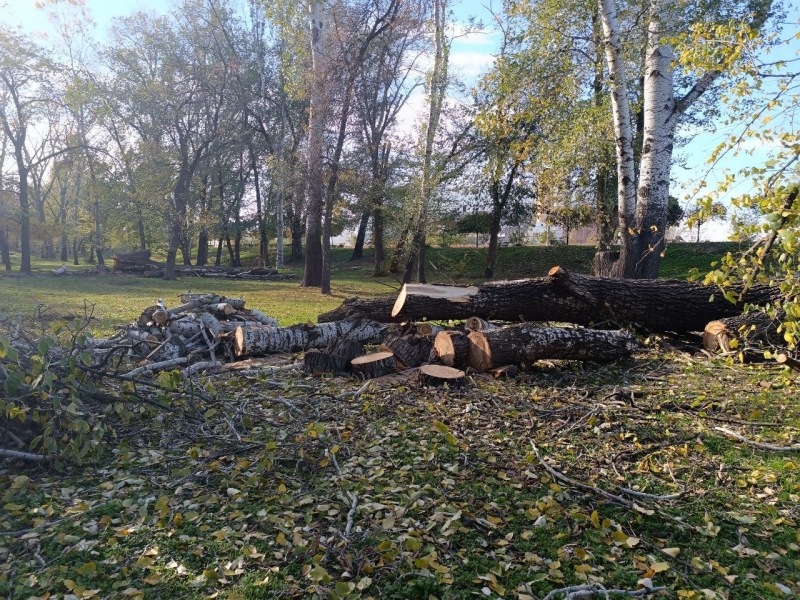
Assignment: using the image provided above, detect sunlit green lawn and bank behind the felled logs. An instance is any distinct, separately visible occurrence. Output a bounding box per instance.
[0,243,732,334]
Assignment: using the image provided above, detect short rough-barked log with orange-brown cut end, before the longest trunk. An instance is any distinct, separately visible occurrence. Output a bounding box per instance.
[467,323,638,371]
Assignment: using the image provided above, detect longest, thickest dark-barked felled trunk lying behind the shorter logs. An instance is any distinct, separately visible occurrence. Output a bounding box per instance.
[319,267,780,332]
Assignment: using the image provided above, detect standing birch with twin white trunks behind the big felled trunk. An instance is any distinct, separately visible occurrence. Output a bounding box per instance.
[596,0,772,278]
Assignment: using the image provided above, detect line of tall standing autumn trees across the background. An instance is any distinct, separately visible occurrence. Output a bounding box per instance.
[0,0,780,293]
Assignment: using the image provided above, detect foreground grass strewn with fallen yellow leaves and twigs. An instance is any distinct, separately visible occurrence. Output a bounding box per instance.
[0,350,800,600]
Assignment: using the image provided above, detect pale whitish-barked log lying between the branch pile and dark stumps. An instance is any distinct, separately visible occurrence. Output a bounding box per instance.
[233,320,386,357]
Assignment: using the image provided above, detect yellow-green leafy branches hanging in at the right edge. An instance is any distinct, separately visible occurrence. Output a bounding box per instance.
[681,16,800,355]
